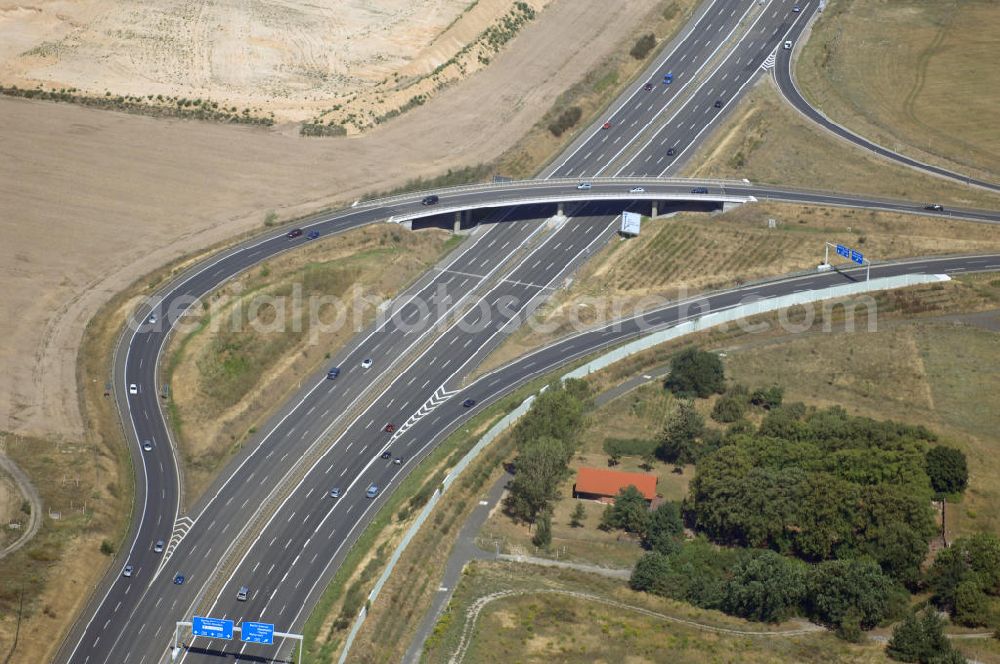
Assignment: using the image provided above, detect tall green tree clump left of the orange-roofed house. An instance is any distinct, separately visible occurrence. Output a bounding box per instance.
[505,380,589,522]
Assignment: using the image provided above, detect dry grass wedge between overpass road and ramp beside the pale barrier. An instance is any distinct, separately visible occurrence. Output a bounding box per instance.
[477,202,1000,374]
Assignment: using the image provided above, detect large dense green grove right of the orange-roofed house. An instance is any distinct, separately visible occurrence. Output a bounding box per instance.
[685,404,935,583]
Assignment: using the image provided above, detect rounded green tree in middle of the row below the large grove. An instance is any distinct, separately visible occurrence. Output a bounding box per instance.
[722,549,806,622]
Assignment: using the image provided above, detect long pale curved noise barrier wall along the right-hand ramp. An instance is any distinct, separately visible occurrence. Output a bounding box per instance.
[338,274,950,664]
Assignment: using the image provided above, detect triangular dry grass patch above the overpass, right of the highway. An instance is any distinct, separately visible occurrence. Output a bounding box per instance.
[683,77,1000,210]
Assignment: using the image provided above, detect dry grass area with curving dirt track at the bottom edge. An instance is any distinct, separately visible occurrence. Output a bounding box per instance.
[423,562,889,664]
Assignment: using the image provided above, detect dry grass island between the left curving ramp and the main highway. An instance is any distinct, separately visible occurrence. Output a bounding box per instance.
[164,224,459,504]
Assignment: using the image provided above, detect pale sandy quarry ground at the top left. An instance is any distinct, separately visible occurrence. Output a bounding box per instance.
[0,0,550,122]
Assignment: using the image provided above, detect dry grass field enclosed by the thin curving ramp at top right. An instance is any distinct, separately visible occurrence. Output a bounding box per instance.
[796,0,1000,182]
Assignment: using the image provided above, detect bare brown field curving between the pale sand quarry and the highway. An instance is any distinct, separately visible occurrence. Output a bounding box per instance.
[0,0,659,440]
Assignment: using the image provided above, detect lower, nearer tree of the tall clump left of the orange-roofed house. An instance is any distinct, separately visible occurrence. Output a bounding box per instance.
[506,436,566,521]
